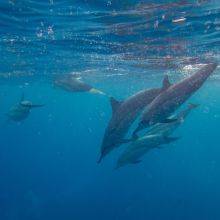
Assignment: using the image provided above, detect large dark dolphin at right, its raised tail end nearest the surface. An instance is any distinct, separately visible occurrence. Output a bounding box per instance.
[133,63,217,138]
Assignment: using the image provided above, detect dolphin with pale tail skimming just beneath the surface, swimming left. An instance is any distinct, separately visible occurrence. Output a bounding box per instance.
[54,74,105,95]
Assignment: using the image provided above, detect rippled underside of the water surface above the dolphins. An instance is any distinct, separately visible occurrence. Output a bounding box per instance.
[0,0,220,78]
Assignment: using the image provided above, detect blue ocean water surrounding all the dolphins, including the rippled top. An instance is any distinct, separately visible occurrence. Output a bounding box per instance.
[0,0,220,220]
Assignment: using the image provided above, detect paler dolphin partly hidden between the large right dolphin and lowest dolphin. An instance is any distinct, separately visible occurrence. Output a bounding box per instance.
[146,103,199,136]
